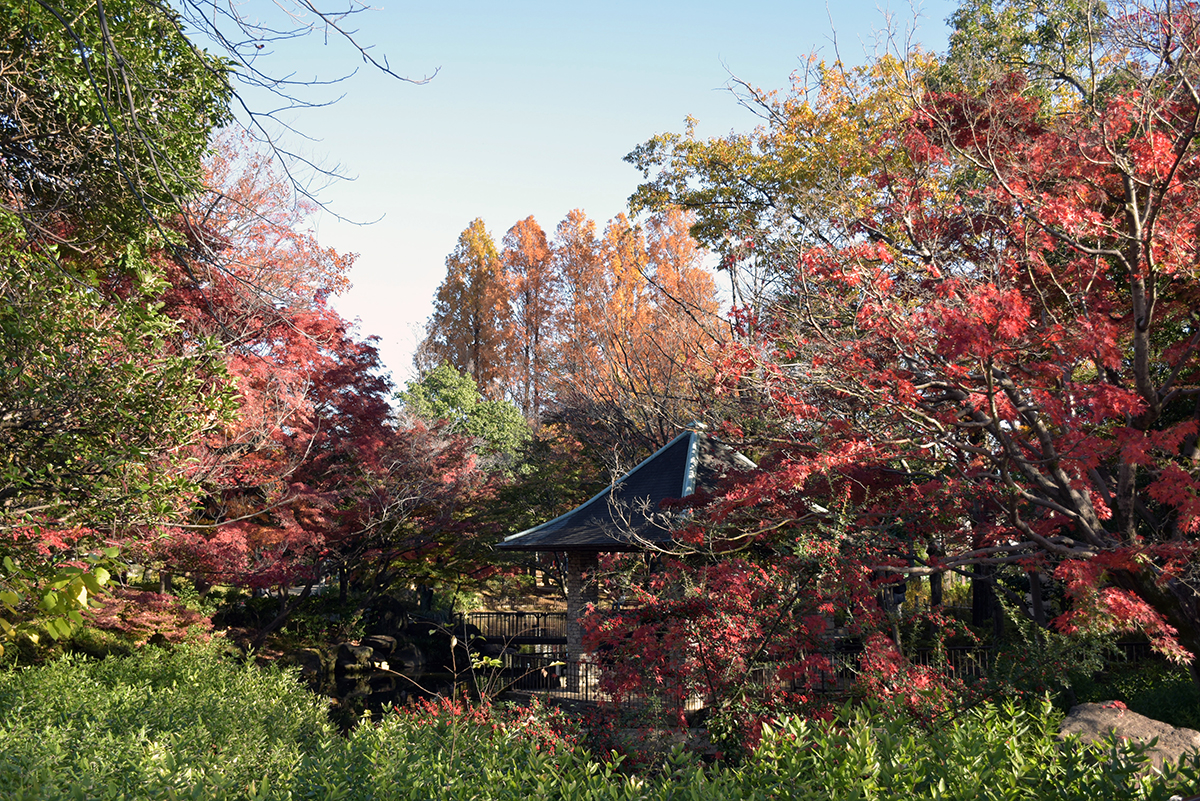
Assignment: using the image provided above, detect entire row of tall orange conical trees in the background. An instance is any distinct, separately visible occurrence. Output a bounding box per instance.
[416,209,721,454]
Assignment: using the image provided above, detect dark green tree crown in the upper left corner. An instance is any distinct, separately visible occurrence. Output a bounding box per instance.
[0,0,230,247]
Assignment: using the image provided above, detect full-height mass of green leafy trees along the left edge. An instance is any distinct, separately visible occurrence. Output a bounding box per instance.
[0,0,230,652]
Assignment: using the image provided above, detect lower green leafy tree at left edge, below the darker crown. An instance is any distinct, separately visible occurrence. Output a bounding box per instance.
[0,227,231,534]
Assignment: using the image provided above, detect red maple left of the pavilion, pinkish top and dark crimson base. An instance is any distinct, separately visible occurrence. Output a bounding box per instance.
[131,137,492,618]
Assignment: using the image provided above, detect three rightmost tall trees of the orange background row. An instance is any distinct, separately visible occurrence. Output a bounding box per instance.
[552,209,721,456]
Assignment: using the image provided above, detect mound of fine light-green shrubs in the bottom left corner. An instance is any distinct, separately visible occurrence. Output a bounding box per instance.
[0,646,335,799]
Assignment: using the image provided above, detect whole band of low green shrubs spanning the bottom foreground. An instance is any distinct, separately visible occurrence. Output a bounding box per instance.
[0,645,1200,801]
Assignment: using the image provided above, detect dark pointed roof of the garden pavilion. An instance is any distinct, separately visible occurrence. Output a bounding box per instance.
[498,432,754,552]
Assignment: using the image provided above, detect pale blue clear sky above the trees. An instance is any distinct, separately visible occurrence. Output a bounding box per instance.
[229,0,955,385]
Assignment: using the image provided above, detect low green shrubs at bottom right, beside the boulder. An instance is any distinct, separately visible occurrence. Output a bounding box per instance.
[744,703,1200,801]
